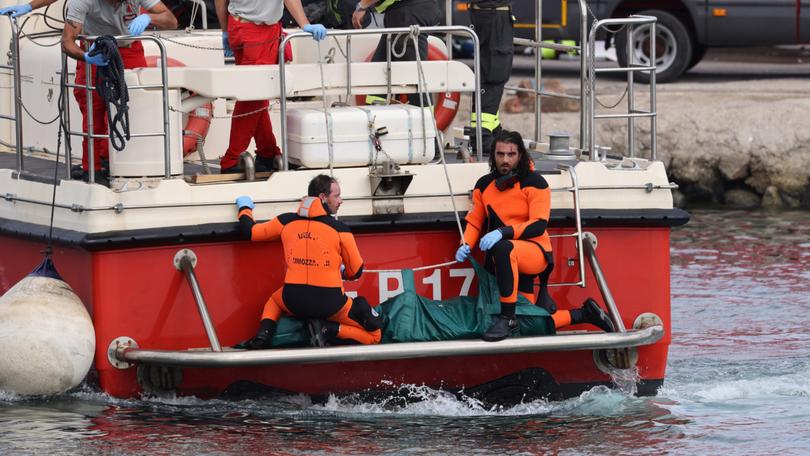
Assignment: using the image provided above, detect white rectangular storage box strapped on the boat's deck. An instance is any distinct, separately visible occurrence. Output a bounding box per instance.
[287,105,436,168]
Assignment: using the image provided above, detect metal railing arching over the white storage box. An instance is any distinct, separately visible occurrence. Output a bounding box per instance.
[278,26,483,170]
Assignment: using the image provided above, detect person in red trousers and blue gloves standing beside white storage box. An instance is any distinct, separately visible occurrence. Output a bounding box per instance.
[214,0,326,174]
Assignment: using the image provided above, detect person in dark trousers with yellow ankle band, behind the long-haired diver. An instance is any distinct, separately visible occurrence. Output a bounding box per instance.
[468,0,515,154]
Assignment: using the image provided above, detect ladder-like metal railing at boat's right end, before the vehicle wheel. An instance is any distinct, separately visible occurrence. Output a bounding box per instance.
[587,15,657,160]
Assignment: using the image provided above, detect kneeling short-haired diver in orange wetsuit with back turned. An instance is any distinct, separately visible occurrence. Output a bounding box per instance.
[235,174,382,350]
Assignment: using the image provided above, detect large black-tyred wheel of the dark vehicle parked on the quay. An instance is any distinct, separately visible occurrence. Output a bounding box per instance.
[615,10,692,82]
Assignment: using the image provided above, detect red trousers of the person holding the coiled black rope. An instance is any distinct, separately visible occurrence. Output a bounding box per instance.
[73,41,146,171]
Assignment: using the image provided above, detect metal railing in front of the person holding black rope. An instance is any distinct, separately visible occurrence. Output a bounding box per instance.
[61,35,171,183]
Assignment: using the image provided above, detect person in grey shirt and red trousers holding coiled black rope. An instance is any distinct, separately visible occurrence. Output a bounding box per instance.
[62,0,177,179]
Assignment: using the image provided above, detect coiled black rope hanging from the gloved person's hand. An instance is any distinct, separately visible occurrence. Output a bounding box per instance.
[90,35,129,151]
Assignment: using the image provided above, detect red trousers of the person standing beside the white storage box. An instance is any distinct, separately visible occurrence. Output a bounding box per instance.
[219,16,281,169]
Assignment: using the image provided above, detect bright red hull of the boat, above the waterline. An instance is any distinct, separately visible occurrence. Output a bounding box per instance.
[0,227,670,397]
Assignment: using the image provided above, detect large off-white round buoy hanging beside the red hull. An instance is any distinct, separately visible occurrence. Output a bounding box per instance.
[0,258,96,395]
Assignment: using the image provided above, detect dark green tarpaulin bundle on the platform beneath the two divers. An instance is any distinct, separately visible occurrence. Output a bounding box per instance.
[273,261,554,346]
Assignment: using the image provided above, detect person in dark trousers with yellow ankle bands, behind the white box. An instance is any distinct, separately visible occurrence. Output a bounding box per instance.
[352,0,442,106]
